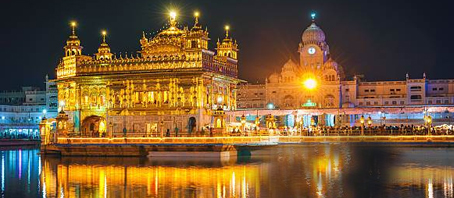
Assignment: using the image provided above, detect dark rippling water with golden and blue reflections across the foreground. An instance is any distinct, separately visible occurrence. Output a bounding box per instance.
[0,144,454,197]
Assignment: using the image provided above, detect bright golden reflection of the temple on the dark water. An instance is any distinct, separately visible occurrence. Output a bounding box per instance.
[41,158,267,197]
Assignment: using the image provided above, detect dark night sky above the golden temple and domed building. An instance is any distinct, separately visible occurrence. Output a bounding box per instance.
[0,0,454,90]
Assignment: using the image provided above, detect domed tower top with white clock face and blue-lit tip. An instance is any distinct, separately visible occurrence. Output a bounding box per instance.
[298,14,329,70]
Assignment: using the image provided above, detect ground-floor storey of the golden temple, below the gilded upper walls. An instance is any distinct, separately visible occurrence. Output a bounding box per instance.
[65,109,234,137]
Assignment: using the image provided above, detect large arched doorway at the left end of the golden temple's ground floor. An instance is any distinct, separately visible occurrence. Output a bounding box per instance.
[80,115,107,137]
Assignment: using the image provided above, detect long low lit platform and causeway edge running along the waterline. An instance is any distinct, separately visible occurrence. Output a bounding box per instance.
[41,135,454,157]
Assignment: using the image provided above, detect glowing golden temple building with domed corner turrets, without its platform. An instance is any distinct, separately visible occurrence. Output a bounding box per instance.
[55,13,240,136]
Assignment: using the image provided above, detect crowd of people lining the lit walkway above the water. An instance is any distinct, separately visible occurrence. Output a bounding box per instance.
[47,124,454,137]
